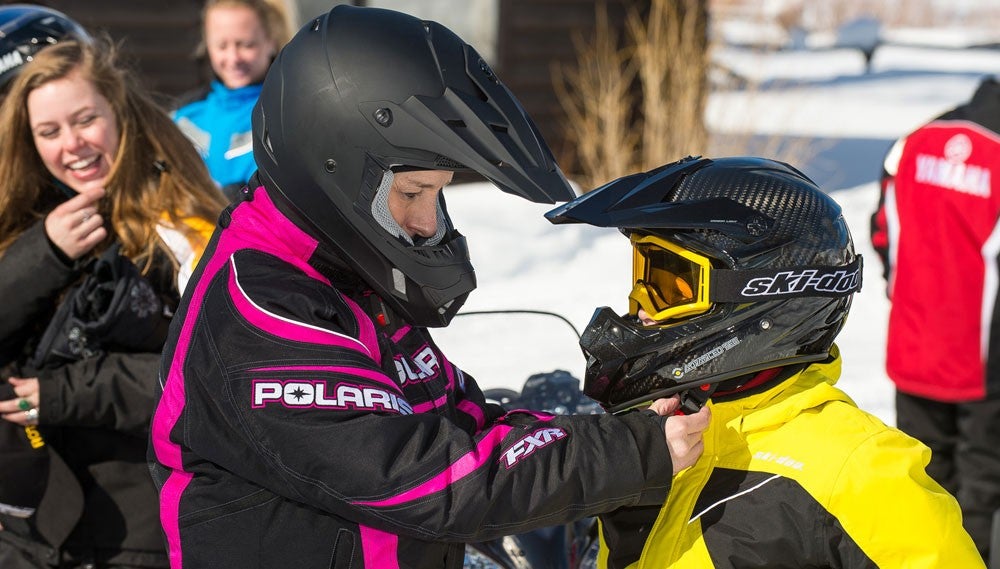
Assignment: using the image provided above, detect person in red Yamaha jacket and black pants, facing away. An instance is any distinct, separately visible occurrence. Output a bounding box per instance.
[871,74,1000,557]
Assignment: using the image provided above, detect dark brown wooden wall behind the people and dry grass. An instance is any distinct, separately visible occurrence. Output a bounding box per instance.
[11,0,649,162]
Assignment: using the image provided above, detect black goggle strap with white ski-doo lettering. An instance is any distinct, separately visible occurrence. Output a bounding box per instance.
[709,255,863,303]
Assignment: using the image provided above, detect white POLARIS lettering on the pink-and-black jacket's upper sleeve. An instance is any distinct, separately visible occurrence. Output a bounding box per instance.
[251,379,413,415]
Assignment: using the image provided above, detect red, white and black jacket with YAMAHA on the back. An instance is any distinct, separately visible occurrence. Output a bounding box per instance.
[871,79,1000,402]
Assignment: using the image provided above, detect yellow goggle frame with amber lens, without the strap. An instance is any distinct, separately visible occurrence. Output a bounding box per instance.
[629,234,712,321]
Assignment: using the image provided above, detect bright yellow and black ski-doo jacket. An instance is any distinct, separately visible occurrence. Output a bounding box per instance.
[600,348,983,569]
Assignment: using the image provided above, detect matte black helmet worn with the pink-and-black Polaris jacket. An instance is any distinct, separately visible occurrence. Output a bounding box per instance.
[253,5,574,326]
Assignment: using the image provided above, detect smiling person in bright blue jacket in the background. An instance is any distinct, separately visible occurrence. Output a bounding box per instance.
[174,0,288,199]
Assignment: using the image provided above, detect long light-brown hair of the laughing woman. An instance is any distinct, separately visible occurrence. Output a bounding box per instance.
[0,38,226,271]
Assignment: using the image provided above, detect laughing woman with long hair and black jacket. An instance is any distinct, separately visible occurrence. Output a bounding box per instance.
[0,37,225,569]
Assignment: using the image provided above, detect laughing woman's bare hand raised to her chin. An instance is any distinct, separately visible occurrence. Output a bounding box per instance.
[45,188,108,261]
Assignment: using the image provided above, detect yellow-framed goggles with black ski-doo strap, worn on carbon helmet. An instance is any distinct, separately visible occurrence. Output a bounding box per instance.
[629,233,862,322]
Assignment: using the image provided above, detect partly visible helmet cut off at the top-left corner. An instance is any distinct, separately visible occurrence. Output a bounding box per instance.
[0,4,90,92]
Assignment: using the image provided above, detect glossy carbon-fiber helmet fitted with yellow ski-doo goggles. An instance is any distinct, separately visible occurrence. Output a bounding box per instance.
[546,157,861,412]
